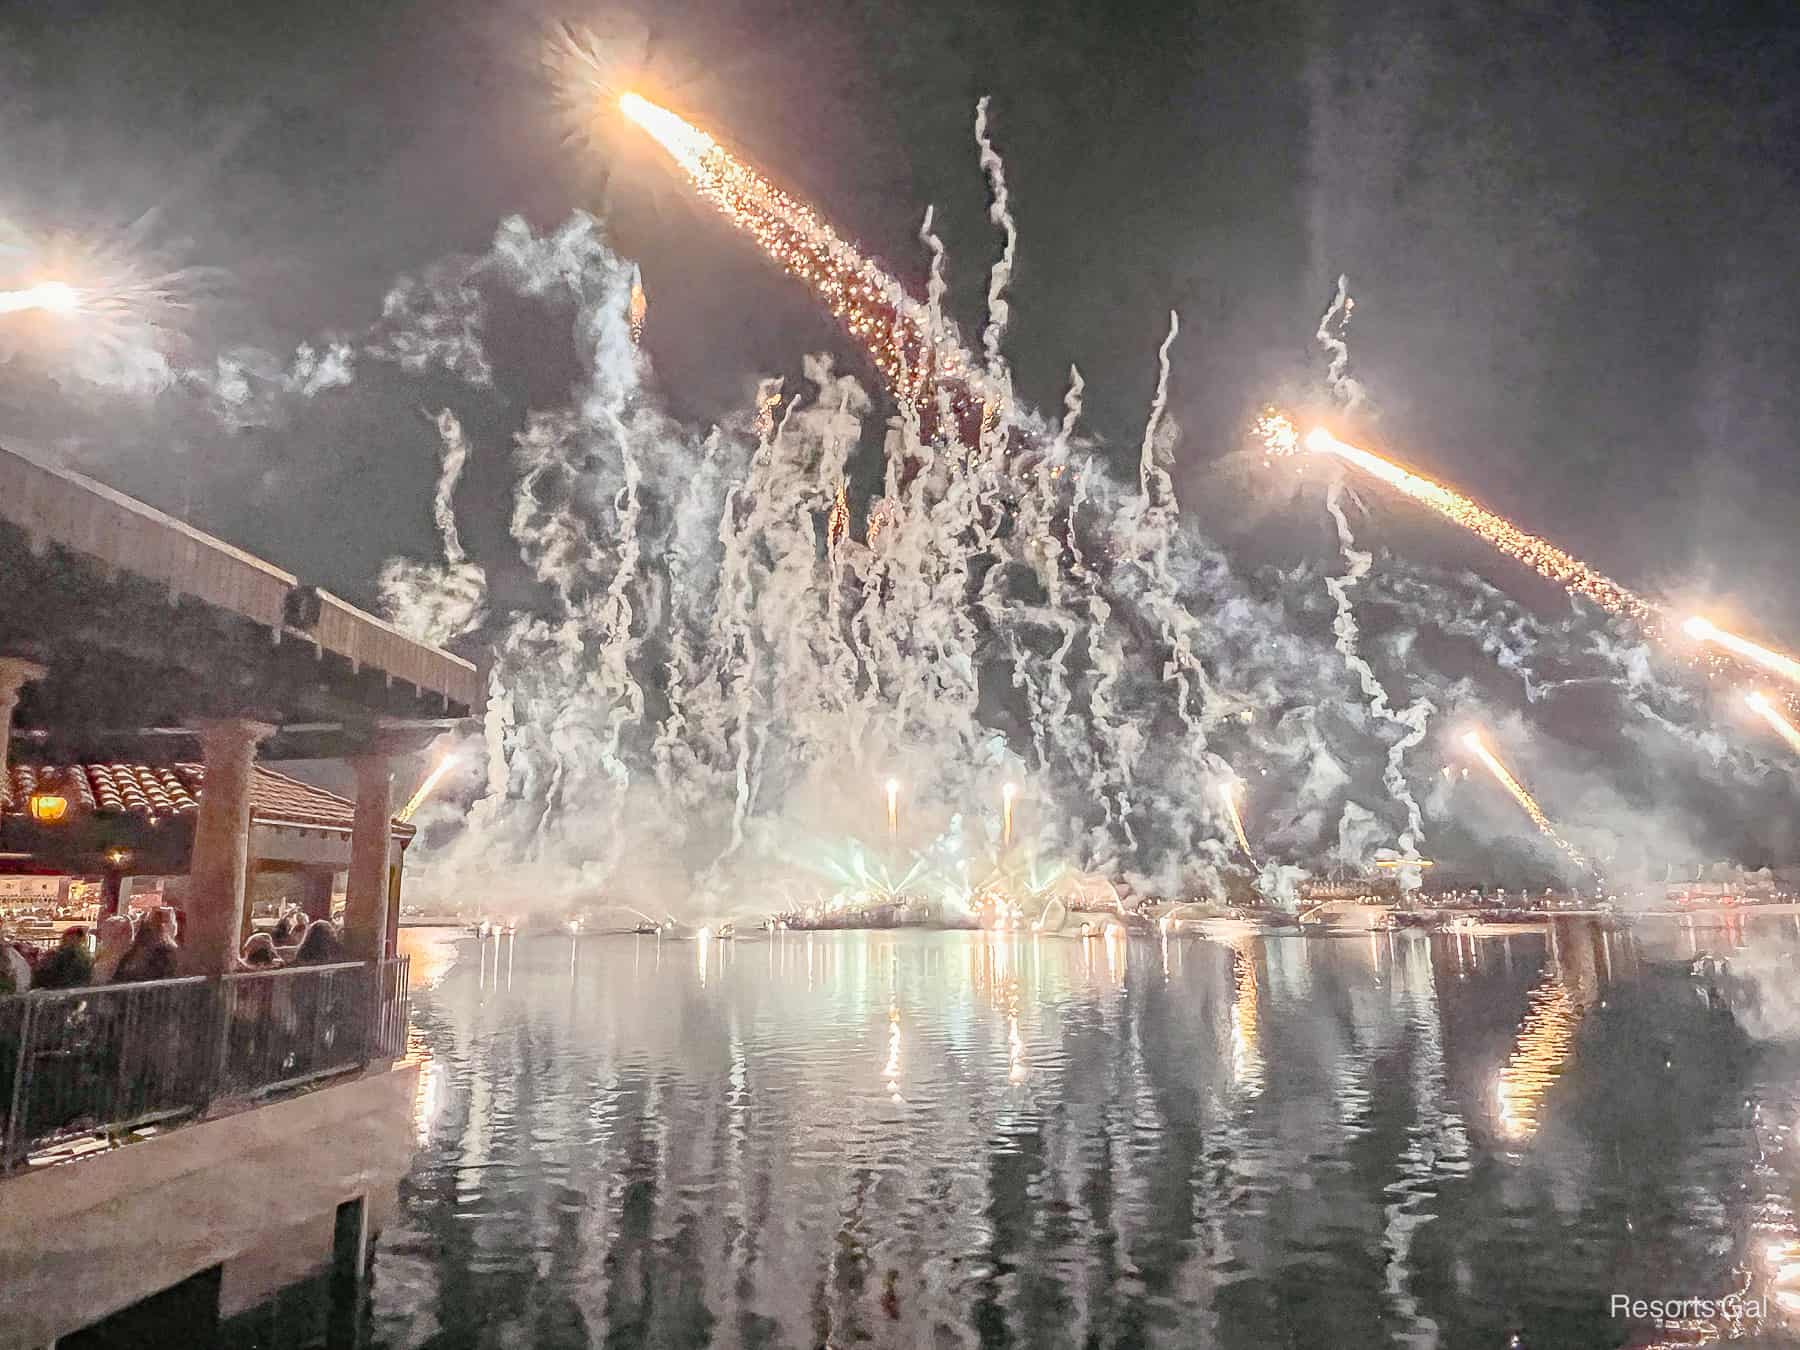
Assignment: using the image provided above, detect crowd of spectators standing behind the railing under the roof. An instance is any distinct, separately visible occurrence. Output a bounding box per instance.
[0,905,344,995]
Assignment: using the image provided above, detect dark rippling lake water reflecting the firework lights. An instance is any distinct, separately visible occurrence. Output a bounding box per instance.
[347,918,1800,1348]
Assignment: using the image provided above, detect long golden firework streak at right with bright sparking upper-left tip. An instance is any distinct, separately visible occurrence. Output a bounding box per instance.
[1255,423,1661,630]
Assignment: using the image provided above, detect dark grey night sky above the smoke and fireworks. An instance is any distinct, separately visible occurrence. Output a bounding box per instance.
[0,0,1800,643]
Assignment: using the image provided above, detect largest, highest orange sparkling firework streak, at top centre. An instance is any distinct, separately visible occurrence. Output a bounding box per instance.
[619,94,983,414]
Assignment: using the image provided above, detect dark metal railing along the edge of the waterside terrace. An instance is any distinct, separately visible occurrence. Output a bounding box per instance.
[0,956,409,1170]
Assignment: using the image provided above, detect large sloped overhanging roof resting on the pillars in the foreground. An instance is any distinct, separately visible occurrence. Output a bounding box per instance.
[0,448,484,765]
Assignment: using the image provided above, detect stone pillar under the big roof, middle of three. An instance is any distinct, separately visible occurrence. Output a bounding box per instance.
[182,718,274,976]
